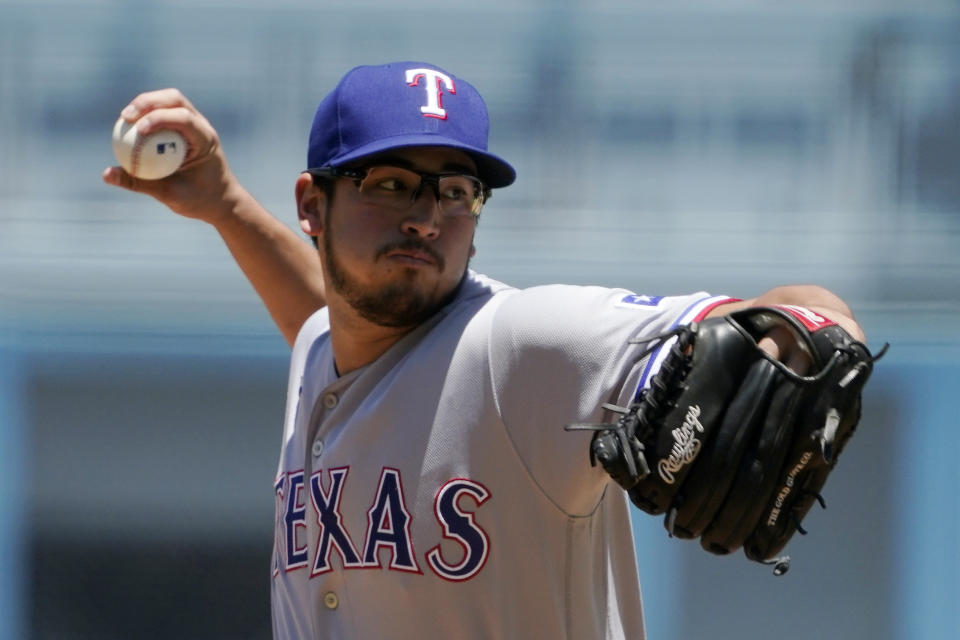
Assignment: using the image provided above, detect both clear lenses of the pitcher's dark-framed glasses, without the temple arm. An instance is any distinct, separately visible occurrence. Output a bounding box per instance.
[360,167,483,216]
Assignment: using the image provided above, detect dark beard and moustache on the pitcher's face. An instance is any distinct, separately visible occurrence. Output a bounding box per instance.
[323,224,469,328]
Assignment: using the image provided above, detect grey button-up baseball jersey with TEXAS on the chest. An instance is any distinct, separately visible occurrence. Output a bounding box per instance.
[272,272,729,640]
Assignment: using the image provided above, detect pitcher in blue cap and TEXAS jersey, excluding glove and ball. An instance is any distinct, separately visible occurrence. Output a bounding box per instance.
[104,62,863,639]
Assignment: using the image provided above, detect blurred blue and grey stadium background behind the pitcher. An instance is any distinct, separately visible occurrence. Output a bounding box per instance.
[0,0,960,640]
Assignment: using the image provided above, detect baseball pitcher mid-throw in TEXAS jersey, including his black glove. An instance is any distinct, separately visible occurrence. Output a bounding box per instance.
[104,62,876,640]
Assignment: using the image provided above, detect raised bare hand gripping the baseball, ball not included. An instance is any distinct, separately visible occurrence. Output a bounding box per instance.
[103,89,243,225]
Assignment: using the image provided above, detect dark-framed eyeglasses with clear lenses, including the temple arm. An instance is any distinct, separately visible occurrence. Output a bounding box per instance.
[307,165,490,217]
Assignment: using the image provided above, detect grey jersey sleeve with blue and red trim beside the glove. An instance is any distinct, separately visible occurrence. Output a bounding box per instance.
[489,285,732,516]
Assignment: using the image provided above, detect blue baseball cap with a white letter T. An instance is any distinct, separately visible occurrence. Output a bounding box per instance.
[307,62,517,188]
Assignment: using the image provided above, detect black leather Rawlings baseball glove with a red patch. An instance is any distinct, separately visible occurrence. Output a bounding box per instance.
[567,306,887,575]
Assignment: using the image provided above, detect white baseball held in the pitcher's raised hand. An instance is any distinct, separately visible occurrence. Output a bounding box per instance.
[113,118,187,180]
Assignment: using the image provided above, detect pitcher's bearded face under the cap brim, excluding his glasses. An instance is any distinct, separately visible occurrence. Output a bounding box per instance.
[301,147,476,327]
